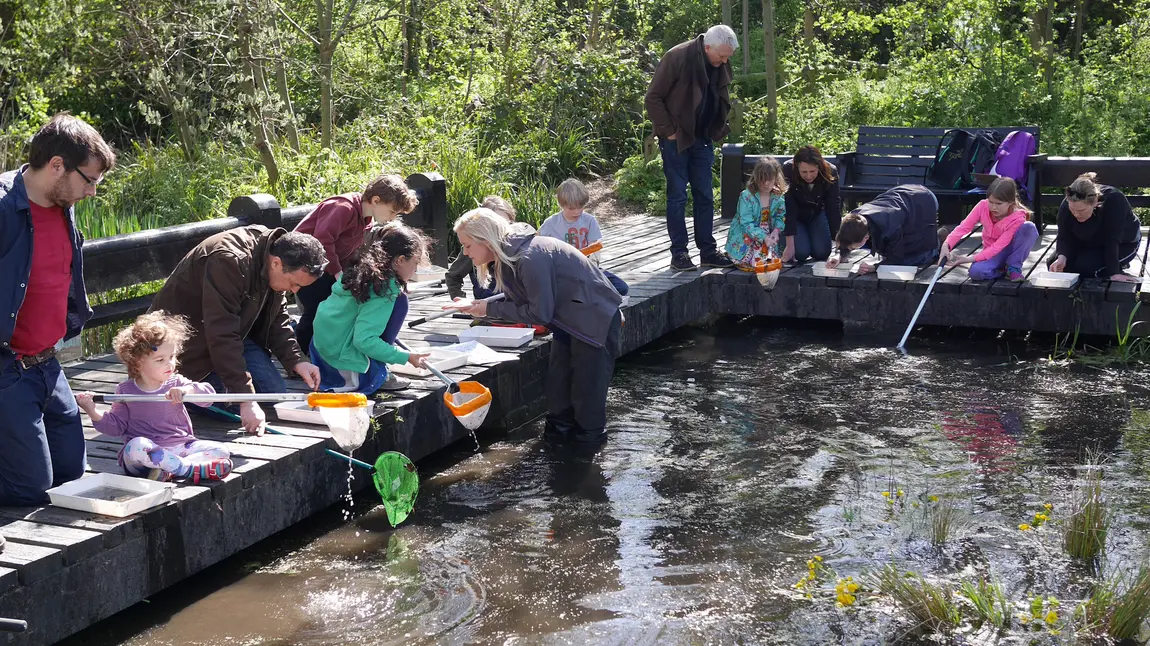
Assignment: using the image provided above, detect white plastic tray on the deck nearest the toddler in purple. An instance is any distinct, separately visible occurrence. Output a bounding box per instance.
[48,474,174,518]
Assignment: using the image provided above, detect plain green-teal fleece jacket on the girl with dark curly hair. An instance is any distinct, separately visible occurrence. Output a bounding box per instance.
[312,274,407,372]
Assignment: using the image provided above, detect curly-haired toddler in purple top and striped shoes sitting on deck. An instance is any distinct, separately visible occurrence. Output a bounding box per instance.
[76,312,231,483]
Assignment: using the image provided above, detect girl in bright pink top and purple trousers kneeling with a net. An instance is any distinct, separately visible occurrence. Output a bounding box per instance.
[938,177,1038,283]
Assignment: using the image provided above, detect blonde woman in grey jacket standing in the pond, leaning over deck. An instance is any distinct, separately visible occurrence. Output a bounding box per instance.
[455,208,622,441]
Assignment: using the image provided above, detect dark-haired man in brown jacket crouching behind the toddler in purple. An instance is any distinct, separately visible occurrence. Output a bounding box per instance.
[152,224,328,433]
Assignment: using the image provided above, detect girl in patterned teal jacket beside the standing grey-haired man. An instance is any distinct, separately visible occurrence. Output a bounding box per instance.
[727,156,787,271]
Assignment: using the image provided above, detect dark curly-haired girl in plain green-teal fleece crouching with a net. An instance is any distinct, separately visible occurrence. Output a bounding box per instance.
[309,222,428,394]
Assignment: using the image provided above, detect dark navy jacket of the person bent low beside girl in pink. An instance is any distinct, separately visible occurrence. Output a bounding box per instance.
[858,184,938,264]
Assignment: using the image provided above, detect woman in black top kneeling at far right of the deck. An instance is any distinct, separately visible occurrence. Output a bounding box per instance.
[1050,172,1142,282]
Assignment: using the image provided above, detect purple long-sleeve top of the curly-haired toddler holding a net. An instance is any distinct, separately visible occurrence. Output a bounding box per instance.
[92,374,215,447]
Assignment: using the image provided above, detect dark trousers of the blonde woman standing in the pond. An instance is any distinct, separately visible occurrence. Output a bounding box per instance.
[546,312,622,440]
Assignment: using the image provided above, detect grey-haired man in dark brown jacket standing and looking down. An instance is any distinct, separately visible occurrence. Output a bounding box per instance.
[644,24,738,271]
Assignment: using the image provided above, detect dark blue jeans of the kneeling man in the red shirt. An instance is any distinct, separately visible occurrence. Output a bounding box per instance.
[0,359,86,505]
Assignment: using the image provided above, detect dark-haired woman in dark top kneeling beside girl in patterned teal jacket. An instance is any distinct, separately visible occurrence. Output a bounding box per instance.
[783,146,842,262]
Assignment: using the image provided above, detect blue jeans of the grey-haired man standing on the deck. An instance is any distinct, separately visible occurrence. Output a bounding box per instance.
[659,138,715,255]
